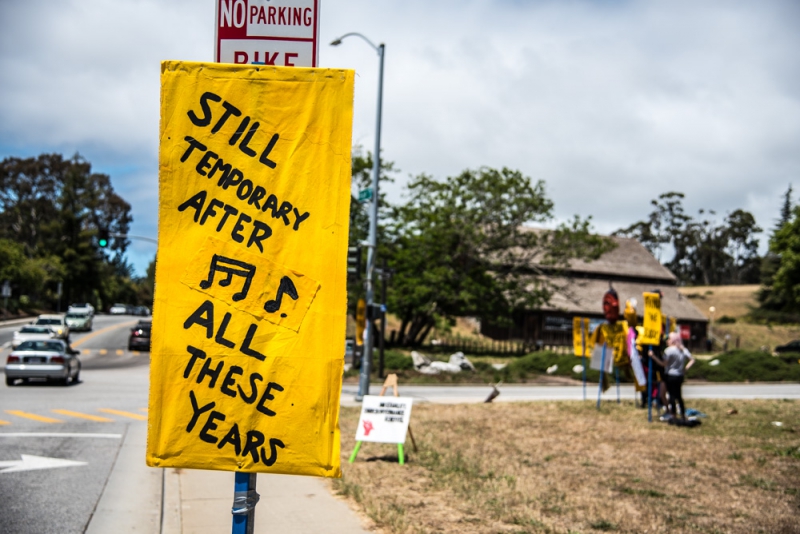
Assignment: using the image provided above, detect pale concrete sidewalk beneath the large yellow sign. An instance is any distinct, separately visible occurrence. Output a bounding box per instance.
[86,418,368,534]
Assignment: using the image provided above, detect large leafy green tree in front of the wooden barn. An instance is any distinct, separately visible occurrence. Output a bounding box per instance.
[381,167,611,346]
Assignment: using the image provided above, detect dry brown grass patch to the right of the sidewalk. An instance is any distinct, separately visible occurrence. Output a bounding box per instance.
[332,400,800,534]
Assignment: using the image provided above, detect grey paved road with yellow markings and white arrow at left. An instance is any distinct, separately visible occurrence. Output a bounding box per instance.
[0,317,150,534]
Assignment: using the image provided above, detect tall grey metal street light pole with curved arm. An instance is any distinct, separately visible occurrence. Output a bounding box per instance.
[331,32,386,401]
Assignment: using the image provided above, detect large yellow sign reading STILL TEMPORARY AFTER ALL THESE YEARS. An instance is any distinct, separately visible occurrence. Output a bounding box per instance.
[147,61,353,477]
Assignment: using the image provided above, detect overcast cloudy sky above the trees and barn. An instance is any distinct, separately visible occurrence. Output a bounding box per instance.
[0,0,800,274]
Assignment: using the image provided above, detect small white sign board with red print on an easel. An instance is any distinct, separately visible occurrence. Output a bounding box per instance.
[356,395,413,444]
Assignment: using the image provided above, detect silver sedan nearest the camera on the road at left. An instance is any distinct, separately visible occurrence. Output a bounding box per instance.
[5,339,81,386]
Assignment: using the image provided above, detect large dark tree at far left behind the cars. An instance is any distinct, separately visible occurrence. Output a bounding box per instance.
[0,154,131,310]
